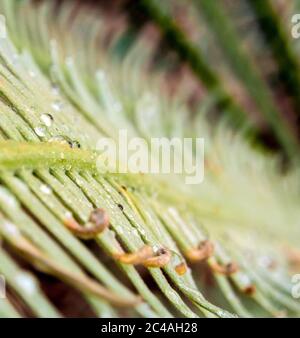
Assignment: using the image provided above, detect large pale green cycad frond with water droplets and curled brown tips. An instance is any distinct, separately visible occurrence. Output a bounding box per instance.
[0,0,300,317]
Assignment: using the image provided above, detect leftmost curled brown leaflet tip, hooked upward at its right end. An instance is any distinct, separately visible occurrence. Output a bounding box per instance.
[64,208,109,239]
